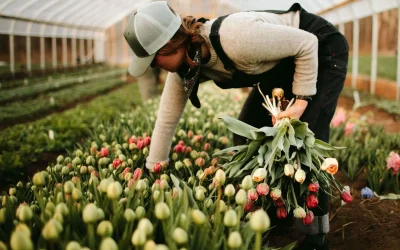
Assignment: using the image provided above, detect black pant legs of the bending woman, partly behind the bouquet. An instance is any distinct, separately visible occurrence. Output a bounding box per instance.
[234,12,348,219]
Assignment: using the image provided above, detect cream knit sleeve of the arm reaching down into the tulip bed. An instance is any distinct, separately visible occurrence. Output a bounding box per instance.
[146,73,188,169]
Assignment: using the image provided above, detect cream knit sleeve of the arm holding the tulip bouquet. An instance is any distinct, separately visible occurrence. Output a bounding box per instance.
[220,14,318,95]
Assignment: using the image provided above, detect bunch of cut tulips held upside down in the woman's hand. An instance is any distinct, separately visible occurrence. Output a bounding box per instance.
[214,85,352,224]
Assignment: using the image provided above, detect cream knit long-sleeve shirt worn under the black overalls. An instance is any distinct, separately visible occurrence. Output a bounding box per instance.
[146,11,318,169]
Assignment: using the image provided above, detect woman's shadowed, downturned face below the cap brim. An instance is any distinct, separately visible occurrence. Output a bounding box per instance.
[151,46,186,72]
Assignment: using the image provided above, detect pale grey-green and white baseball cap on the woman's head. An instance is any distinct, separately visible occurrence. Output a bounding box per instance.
[124,1,182,77]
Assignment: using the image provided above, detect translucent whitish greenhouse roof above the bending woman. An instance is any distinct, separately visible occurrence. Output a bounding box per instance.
[0,0,399,37]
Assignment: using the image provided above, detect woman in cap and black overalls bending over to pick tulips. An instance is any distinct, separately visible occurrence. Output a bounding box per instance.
[124,2,348,249]
